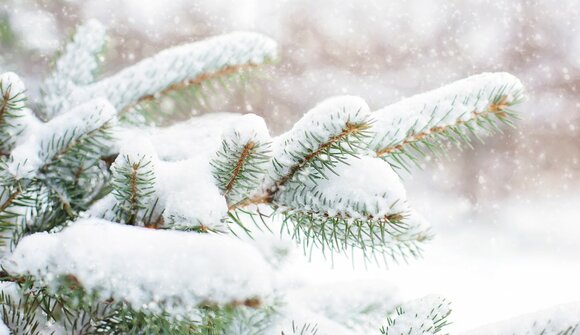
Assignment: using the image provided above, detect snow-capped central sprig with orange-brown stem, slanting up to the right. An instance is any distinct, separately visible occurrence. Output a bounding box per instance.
[265,96,371,200]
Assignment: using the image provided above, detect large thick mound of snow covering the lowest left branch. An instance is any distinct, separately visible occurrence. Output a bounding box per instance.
[7,219,272,316]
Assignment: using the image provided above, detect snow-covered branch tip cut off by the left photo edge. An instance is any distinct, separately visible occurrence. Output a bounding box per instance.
[0,72,26,154]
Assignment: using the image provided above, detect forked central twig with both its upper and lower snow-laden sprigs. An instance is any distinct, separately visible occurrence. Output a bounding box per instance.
[221,96,430,261]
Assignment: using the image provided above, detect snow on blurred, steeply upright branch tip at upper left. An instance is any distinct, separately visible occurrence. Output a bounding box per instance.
[43,20,106,119]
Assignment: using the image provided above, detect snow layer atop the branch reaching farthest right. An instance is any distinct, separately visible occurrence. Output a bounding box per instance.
[371,72,524,151]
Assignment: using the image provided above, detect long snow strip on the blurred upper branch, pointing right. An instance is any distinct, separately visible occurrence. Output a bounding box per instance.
[71,32,277,110]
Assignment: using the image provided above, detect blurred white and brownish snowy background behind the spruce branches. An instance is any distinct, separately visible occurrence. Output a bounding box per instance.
[0,0,580,332]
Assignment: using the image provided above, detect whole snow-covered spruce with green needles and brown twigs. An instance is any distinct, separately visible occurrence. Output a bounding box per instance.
[0,21,575,334]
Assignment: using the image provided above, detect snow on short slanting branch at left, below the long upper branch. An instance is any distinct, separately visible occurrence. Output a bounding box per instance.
[8,99,116,179]
